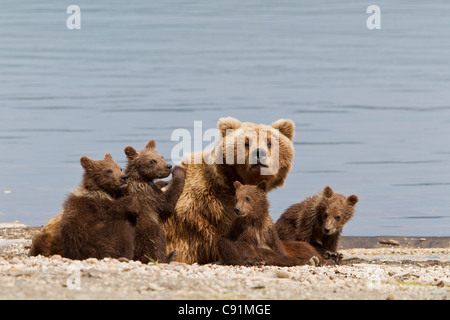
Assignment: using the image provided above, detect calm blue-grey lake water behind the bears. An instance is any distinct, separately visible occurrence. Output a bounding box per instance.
[0,0,450,236]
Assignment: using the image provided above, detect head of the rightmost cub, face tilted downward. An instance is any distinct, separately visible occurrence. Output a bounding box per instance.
[321,186,358,235]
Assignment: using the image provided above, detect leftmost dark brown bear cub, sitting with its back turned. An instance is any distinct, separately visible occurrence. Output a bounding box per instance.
[60,154,139,260]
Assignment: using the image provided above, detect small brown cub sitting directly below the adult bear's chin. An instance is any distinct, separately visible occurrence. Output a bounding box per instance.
[217,181,320,266]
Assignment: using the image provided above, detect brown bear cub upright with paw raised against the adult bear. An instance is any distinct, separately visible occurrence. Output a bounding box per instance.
[125,140,185,263]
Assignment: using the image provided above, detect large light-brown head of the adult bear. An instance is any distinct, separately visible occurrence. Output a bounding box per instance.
[215,117,295,191]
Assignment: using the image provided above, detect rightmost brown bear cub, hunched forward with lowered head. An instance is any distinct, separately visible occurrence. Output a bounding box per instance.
[275,186,358,256]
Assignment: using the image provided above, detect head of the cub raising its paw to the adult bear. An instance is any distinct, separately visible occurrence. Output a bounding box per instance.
[124,140,172,181]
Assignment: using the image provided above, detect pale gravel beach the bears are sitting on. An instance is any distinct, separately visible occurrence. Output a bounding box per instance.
[0,224,450,300]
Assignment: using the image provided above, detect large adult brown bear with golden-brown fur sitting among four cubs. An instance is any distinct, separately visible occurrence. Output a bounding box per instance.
[163,117,295,263]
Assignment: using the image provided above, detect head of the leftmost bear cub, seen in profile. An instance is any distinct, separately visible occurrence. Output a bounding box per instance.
[80,153,128,195]
